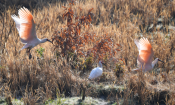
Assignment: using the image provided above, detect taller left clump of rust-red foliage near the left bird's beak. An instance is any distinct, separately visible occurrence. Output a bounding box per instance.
[52,2,93,56]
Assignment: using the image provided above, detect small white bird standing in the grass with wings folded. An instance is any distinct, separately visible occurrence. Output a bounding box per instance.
[88,61,104,79]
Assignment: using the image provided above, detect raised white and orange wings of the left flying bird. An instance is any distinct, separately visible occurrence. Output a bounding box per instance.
[11,7,37,43]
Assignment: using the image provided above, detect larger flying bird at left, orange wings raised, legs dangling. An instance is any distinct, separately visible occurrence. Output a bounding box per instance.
[11,7,52,59]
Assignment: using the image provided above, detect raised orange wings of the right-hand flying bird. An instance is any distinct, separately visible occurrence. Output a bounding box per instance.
[134,38,154,65]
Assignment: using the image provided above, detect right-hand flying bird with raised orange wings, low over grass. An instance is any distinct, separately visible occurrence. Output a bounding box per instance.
[132,37,164,72]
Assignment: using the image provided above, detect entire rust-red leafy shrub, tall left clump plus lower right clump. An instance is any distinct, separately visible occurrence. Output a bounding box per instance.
[52,2,120,59]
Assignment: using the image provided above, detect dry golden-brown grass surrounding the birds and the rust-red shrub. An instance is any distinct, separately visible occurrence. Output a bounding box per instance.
[0,0,175,105]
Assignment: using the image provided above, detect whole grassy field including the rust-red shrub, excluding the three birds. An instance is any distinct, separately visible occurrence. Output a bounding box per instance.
[0,0,175,105]
